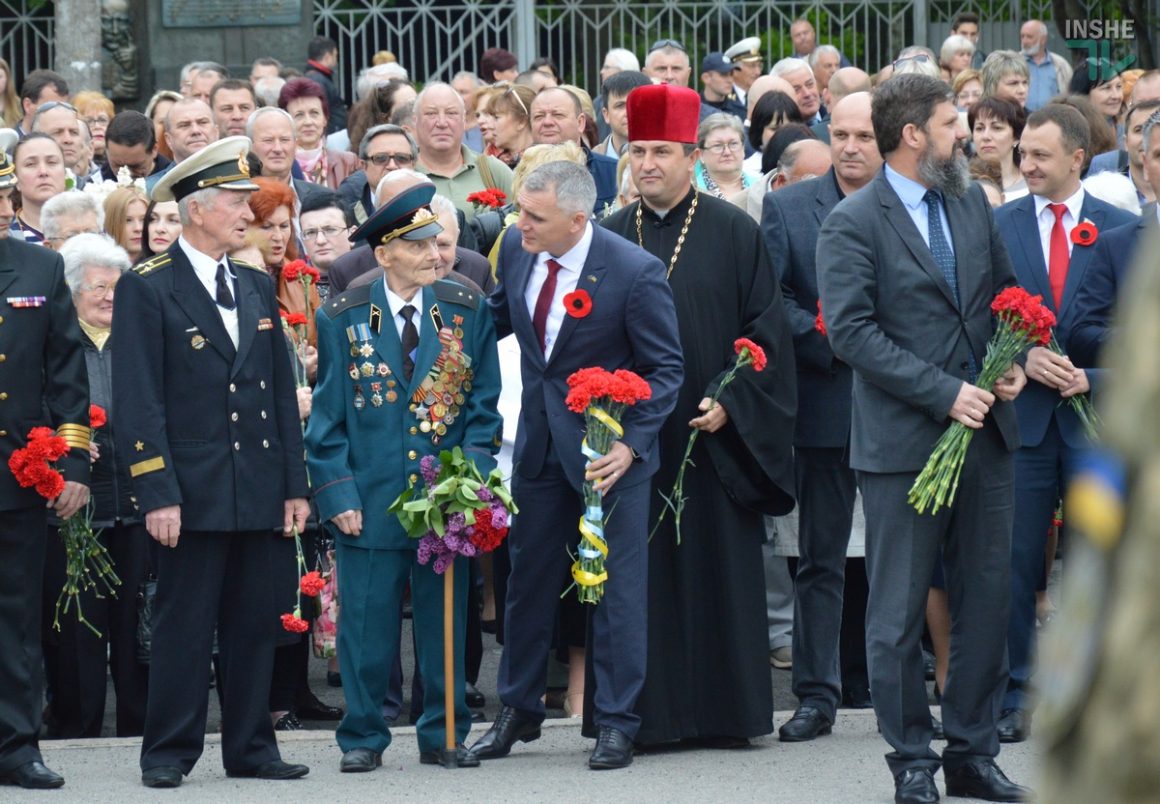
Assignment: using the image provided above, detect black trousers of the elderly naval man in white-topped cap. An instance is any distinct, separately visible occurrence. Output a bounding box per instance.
[140,530,280,775]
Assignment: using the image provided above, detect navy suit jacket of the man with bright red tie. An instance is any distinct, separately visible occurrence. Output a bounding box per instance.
[995,193,1134,448]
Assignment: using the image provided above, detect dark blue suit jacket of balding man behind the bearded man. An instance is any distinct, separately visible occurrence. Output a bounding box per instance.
[761,168,854,448]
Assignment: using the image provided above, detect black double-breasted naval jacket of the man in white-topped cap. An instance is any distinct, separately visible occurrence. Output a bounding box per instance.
[111,242,307,531]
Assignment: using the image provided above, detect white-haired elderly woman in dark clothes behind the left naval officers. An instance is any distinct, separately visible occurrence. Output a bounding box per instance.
[44,233,153,739]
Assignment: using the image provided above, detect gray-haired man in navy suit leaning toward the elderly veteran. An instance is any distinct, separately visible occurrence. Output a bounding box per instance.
[471,162,683,769]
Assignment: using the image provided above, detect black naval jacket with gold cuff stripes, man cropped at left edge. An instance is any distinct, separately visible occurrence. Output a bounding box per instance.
[0,236,89,508]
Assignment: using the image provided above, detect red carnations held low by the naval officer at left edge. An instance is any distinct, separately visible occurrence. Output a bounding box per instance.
[8,405,121,637]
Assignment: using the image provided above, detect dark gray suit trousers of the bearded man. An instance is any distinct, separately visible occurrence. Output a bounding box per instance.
[858,417,1014,775]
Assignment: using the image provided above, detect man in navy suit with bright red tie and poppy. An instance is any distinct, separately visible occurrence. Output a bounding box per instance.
[995,104,1132,743]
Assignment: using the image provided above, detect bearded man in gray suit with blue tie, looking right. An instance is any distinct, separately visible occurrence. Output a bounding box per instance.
[818,74,1030,804]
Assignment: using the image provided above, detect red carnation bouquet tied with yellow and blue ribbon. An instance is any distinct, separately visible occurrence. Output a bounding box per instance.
[565,367,652,603]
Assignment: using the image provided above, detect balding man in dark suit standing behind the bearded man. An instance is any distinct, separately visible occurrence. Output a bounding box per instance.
[761,92,882,743]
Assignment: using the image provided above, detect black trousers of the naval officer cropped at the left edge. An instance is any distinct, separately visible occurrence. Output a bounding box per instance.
[0,504,49,774]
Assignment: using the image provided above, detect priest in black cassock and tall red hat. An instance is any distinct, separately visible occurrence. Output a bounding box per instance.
[604,84,797,747]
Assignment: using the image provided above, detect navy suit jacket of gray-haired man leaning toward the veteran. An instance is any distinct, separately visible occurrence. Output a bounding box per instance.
[487,224,684,492]
